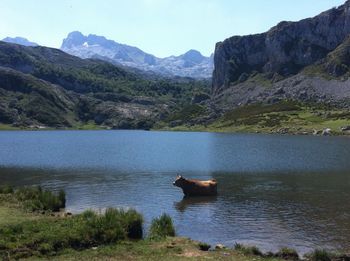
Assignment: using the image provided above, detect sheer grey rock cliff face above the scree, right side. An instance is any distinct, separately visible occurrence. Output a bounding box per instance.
[213,0,350,95]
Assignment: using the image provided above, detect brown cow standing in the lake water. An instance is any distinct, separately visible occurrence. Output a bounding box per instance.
[173,176,217,197]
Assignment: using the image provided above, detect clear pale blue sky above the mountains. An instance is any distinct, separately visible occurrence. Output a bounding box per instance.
[0,0,345,57]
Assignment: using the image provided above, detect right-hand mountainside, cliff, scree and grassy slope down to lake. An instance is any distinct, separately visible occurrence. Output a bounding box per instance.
[163,1,350,134]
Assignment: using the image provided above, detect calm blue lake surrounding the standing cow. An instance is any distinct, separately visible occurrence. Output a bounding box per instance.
[0,131,350,253]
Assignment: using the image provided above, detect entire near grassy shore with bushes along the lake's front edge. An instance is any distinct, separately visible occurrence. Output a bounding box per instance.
[0,187,350,261]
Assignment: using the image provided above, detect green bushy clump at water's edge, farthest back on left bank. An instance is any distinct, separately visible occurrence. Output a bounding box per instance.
[15,186,66,212]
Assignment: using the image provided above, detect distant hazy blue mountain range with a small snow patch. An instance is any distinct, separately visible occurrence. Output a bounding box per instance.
[61,31,213,78]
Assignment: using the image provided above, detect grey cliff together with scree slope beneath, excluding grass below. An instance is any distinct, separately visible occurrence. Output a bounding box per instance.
[212,0,350,108]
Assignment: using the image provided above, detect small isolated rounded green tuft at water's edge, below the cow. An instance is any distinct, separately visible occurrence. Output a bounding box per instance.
[148,214,175,239]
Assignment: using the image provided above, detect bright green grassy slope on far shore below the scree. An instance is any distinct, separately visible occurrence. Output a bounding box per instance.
[165,101,350,135]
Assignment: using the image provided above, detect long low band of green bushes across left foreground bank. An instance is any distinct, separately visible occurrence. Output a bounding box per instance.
[0,208,143,259]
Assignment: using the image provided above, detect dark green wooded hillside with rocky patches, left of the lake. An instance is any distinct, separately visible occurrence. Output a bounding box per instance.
[0,41,209,129]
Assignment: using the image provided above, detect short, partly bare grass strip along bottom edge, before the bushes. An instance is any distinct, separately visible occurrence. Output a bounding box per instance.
[23,237,281,261]
